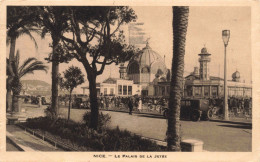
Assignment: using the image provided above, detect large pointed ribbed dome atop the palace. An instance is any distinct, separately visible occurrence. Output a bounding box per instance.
[127,43,167,74]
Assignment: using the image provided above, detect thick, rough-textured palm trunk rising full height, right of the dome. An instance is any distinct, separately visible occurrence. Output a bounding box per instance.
[167,7,189,151]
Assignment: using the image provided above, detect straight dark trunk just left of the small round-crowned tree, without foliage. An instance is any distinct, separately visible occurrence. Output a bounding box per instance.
[51,36,59,118]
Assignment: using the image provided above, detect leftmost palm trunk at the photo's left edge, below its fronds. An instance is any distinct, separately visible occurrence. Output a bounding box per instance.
[6,37,16,111]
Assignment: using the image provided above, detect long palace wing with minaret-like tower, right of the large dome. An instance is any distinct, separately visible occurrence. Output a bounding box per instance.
[154,47,252,98]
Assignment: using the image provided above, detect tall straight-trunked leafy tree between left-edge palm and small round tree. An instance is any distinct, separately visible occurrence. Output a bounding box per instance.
[37,6,68,117]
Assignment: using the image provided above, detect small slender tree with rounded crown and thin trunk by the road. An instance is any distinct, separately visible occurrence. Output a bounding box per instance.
[60,66,84,121]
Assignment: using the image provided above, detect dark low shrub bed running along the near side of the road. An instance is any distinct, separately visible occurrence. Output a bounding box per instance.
[22,117,162,151]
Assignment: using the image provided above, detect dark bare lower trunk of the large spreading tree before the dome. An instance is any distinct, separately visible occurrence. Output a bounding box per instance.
[87,72,98,130]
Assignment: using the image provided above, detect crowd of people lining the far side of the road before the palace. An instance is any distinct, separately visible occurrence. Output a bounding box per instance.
[24,95,252,117]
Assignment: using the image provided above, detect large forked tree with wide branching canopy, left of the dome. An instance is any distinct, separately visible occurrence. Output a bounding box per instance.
[62,6,136,129]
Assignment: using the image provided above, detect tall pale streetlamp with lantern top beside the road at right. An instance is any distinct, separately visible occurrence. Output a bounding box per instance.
[222,30,230,120]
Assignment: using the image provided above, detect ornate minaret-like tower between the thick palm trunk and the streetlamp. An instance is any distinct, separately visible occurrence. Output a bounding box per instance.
[199,47,211,80]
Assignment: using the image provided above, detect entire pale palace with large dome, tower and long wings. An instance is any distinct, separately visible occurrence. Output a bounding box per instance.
[82,46,252,98]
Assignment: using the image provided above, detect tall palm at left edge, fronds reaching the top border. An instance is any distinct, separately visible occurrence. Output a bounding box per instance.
[6,6,39,112]
